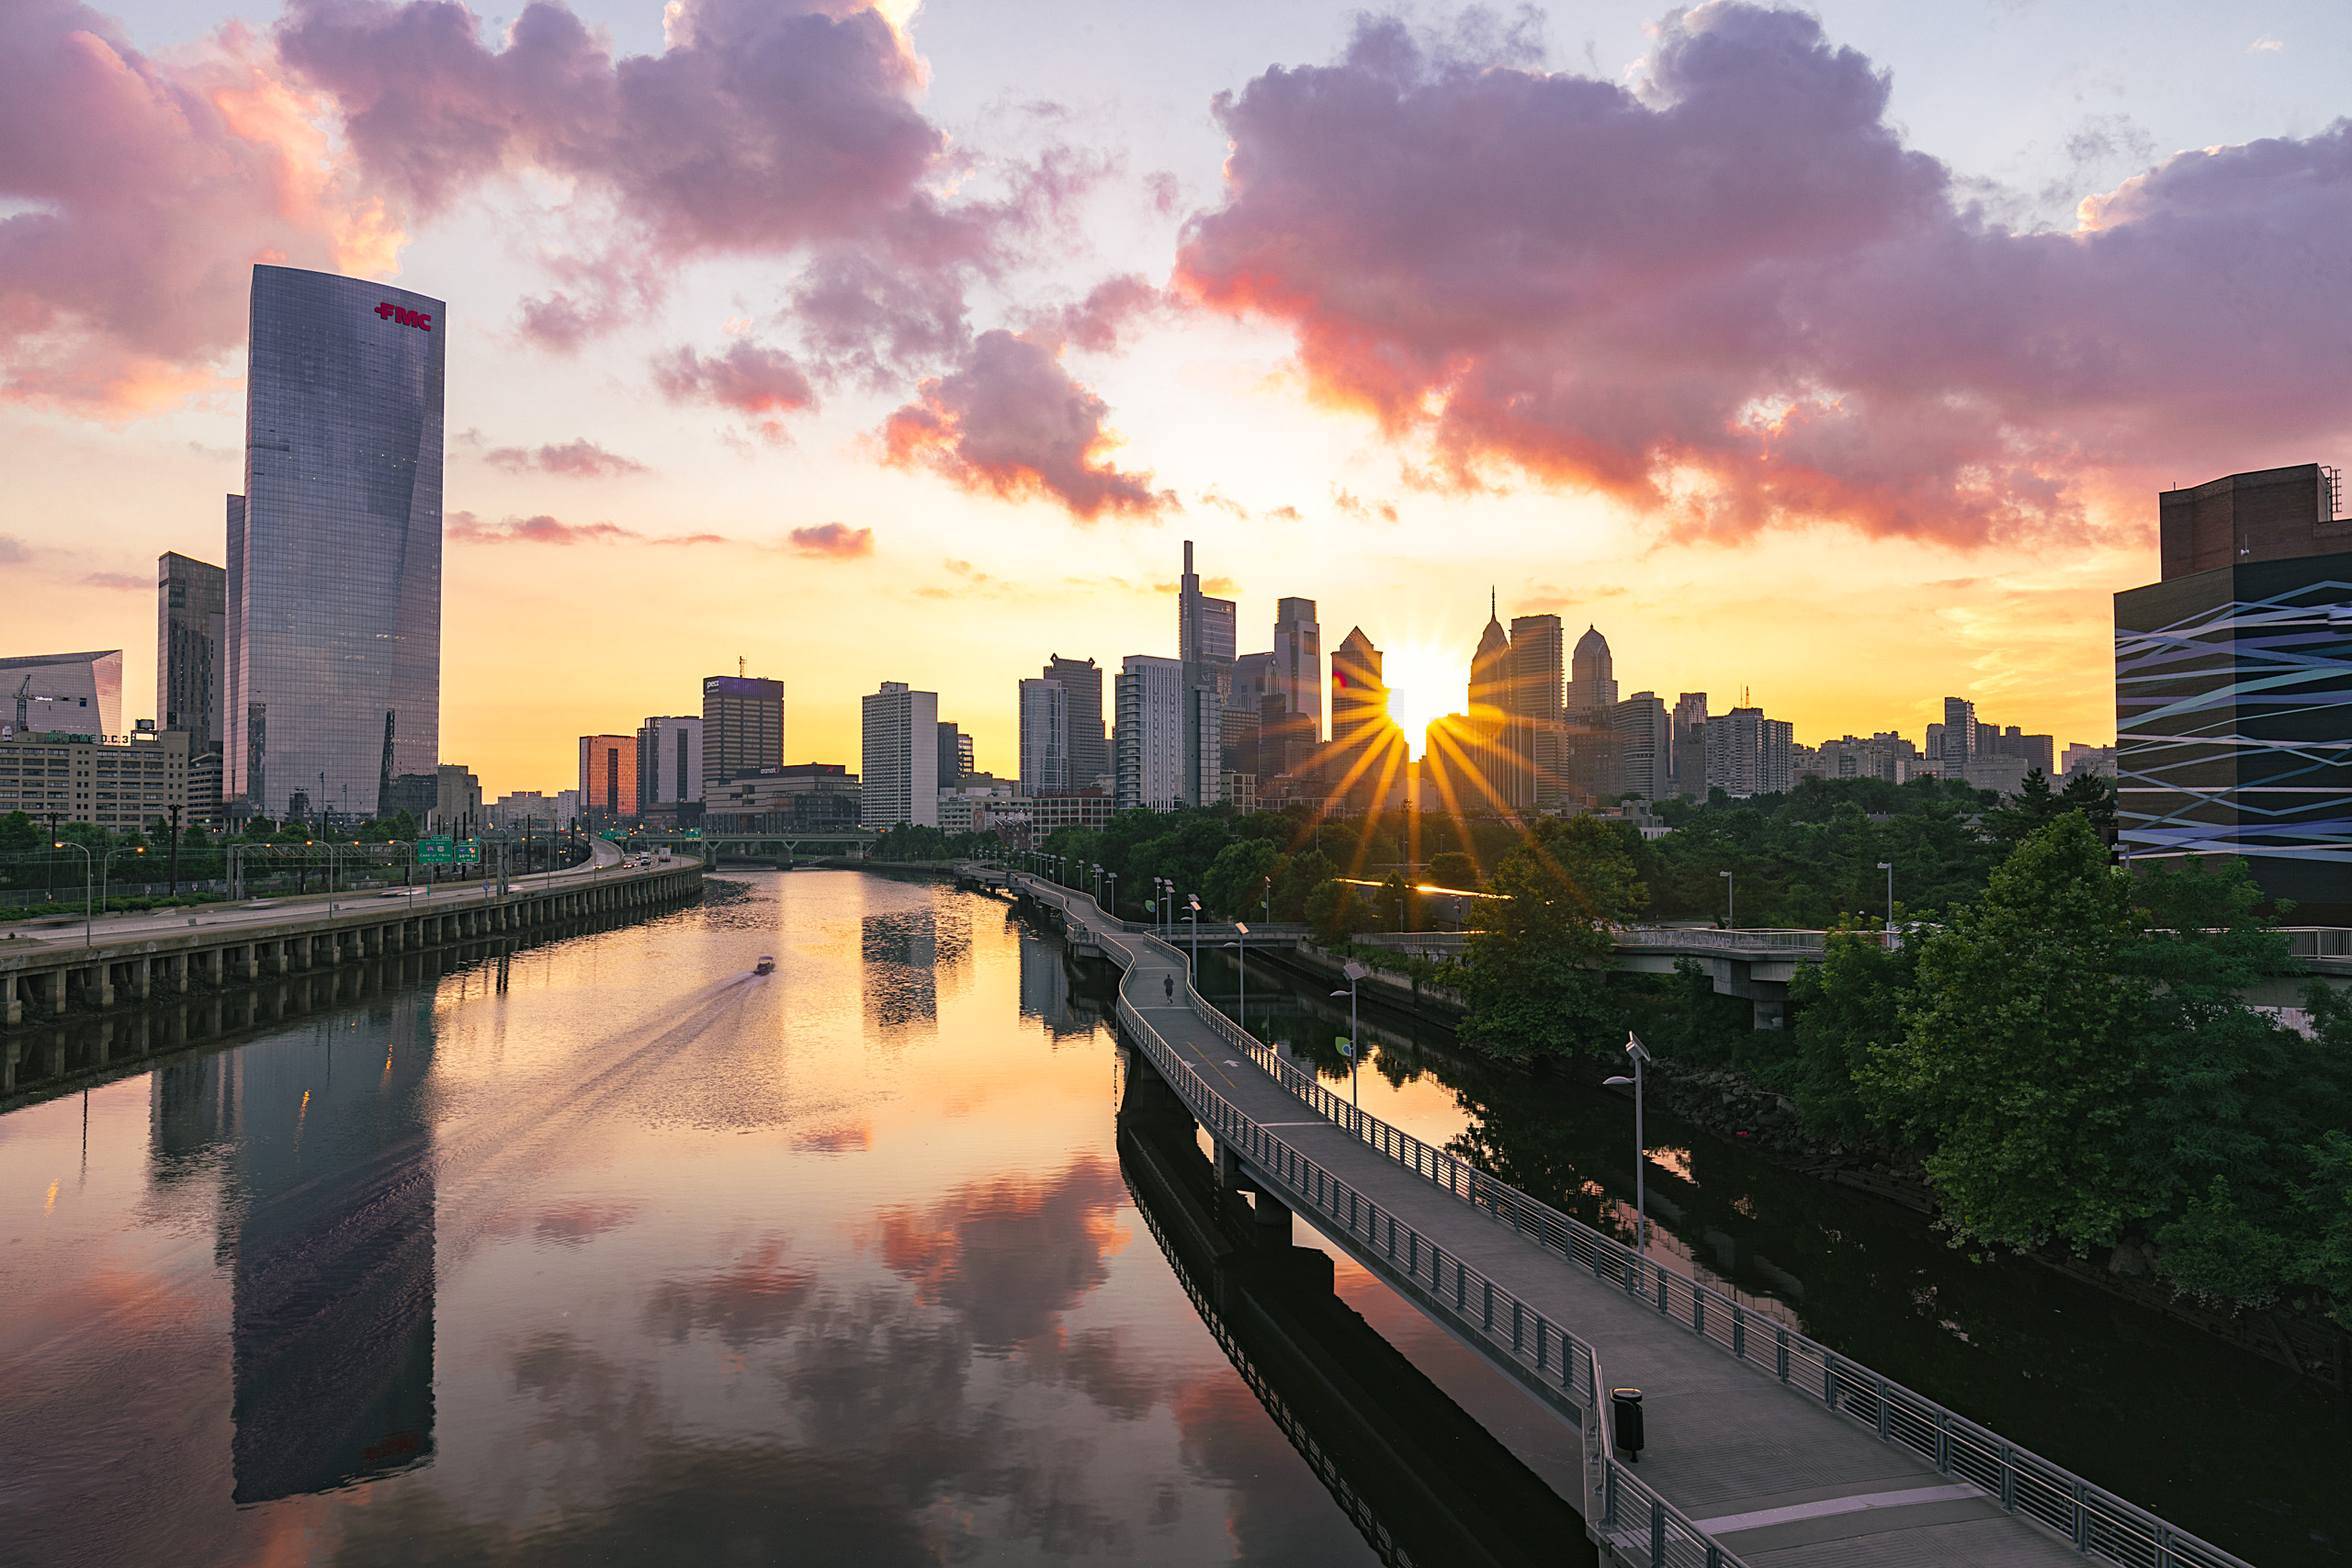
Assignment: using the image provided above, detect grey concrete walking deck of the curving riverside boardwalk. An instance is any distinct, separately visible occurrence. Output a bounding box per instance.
[1013,877,2242,1568]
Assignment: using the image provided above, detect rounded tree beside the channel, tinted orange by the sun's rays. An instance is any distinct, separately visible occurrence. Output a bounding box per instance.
[1458,816,1646,1055]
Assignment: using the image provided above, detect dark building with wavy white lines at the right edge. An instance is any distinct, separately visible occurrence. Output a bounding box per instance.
[2114,463,2352,926]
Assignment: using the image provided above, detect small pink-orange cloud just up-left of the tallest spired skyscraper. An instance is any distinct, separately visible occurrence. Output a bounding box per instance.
[882,332,1179,522]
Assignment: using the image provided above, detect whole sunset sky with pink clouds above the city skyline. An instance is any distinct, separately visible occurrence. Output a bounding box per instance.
[14,0,2352,795]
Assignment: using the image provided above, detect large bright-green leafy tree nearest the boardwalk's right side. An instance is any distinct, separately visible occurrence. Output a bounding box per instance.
[1856,813,2162,1248]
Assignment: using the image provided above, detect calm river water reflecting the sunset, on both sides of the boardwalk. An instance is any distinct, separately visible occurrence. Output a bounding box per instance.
[0,872,2352,1568]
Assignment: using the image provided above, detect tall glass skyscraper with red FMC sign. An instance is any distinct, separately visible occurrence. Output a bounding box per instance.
[223,265,449,818]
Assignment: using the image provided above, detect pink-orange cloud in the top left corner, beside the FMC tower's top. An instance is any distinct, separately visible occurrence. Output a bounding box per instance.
[0,0,400,419]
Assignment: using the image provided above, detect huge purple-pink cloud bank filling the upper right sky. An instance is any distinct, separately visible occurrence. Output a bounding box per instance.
[1179,3,2352,546]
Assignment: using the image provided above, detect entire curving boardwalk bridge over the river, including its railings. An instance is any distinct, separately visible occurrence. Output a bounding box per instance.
[1012,874,2246,1568]
